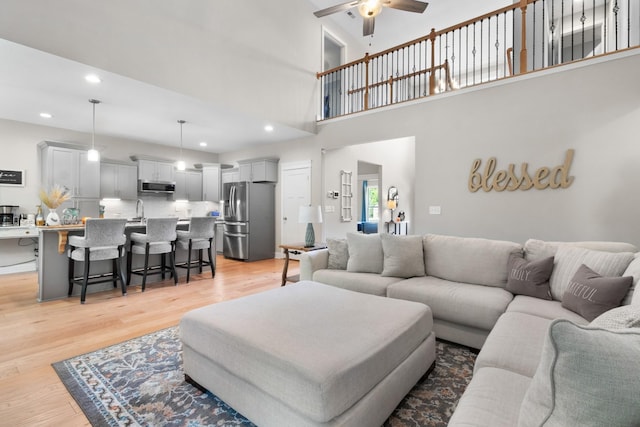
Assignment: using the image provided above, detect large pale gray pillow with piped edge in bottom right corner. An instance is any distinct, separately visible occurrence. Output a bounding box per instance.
[518,320,640,427]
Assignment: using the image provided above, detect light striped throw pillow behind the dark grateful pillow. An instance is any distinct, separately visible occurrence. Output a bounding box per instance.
[549,245,633,301]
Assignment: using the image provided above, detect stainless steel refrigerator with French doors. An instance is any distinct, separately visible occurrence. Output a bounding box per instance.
[223,182,276,261]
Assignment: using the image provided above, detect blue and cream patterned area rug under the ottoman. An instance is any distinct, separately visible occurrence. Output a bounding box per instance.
[53,326,476,427]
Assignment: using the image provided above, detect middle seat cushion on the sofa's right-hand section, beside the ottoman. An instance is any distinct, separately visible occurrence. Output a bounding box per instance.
[473,311,553,378]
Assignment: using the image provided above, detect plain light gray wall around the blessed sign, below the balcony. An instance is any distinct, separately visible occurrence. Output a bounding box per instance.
[318,50,640,246]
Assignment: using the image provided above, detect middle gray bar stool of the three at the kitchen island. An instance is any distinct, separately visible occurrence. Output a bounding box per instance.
[127,218,178,292]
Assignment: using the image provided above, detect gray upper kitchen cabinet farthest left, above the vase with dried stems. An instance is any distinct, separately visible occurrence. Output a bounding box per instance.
[40,142,100,199]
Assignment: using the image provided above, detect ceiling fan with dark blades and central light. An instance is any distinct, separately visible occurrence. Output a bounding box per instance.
[313,0,429,37]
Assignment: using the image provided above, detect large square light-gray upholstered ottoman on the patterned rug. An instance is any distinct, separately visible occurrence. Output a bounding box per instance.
[180,281,435,427]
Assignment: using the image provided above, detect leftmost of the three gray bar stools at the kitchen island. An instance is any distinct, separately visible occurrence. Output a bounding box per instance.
[67,218,127,304]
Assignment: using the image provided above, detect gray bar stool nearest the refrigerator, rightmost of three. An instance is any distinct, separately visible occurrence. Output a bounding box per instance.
[176,216,216,283]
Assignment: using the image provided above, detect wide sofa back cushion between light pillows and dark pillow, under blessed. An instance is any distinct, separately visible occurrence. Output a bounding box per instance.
[424,234,522,288]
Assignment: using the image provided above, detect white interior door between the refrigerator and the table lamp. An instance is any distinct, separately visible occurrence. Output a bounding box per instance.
[280,161,311,259]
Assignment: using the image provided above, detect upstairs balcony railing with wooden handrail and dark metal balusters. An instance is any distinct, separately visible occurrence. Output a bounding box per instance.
[317,0,640,120]
